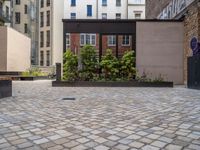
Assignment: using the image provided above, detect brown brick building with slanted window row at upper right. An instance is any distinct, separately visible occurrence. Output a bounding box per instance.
[146,0,200,82]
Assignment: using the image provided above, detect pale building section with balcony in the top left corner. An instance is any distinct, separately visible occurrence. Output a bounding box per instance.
[0,0,11,26]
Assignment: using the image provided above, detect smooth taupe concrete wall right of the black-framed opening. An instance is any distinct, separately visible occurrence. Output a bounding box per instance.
[136,22,184,84]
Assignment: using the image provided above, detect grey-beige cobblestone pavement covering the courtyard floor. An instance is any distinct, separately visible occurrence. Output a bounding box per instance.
[0,81,200,150]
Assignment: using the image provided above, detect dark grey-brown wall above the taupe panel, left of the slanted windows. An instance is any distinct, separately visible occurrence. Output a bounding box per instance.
[146,0,171,19]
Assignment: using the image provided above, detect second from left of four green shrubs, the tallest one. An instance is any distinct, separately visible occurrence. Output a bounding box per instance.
[79,45,98,81]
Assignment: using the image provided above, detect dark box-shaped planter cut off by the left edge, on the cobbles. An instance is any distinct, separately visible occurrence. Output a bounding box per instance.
[0,78,12,98]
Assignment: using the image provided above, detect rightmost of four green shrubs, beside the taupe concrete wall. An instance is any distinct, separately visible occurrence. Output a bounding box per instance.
[121,51,136,80]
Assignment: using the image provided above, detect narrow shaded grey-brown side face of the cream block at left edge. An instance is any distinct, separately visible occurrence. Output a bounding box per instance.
[0,26,7,71]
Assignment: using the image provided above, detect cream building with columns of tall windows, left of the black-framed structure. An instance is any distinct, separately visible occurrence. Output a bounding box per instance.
[38,0,64,67]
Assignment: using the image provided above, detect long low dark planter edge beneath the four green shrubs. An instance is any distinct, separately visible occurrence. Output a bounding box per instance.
[52,81,173,88]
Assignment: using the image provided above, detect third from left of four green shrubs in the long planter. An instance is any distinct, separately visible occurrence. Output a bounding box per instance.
[100,49,120,80]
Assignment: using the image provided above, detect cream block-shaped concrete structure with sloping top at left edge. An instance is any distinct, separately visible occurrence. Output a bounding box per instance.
[0,27,31,72]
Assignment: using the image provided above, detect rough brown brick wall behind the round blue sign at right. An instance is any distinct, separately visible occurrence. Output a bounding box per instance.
[184,3,200,83]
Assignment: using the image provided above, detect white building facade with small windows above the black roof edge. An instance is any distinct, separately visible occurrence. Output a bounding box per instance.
[64,0,145,19]
